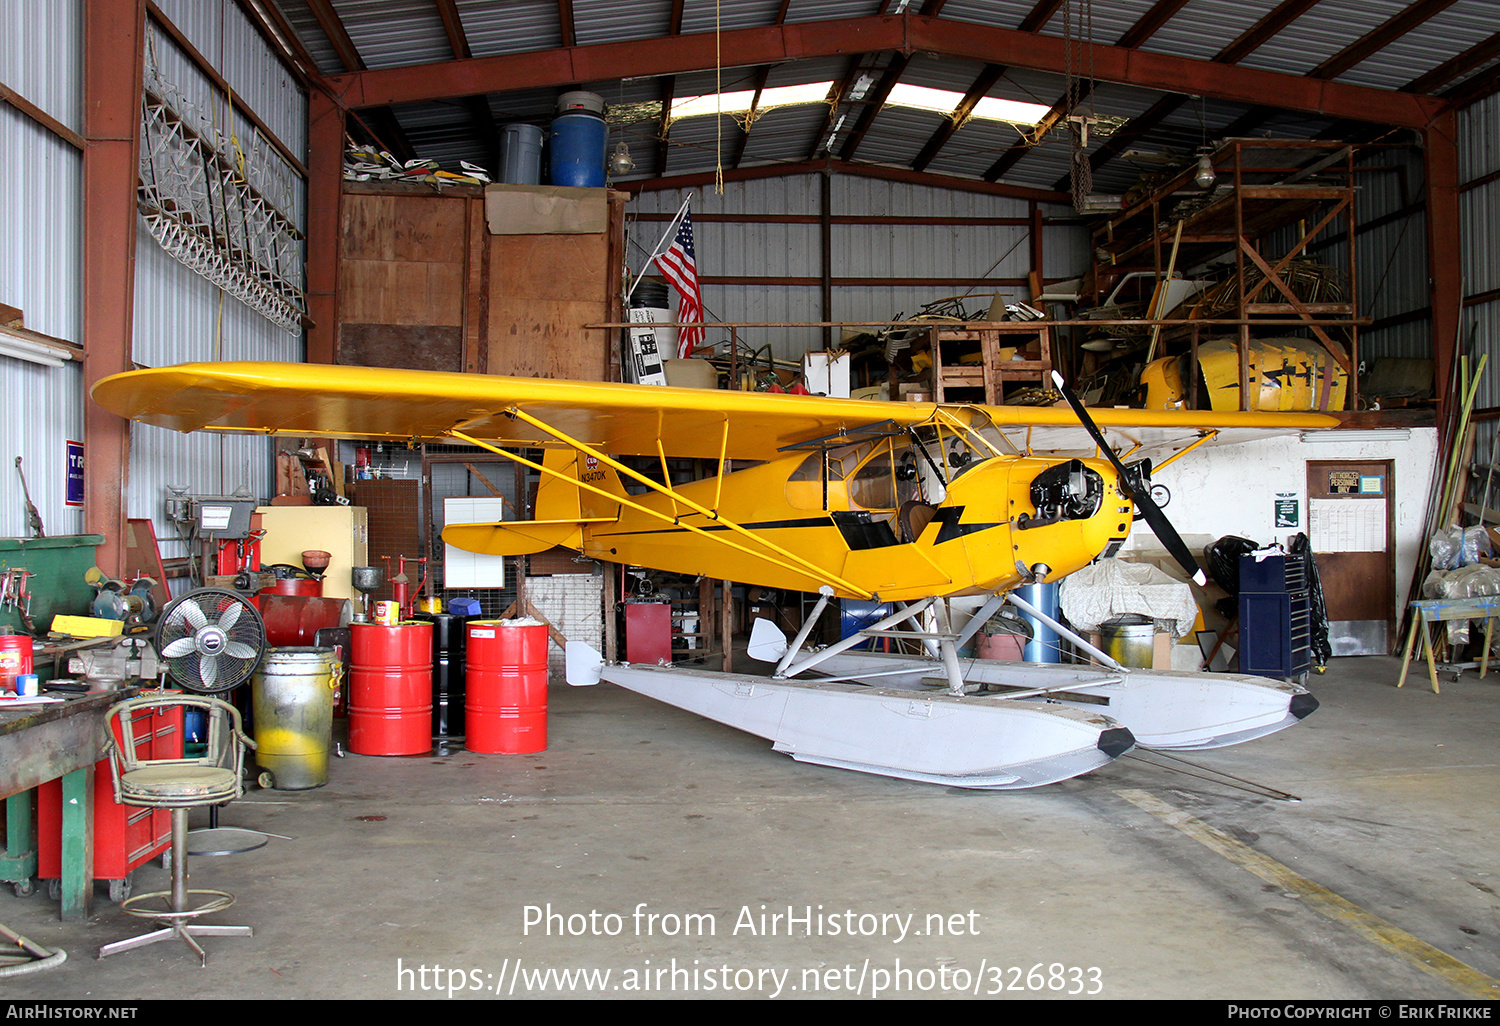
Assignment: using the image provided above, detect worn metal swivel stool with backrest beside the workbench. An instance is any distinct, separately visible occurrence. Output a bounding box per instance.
[99,695,255,966]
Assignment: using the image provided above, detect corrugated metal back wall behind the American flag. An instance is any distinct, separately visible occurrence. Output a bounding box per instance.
[627,174,1088,360]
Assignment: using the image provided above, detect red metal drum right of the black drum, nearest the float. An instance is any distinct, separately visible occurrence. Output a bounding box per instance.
[464,620,549,755]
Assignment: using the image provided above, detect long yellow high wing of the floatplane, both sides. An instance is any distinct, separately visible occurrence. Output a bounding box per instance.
[93,362,1338,461]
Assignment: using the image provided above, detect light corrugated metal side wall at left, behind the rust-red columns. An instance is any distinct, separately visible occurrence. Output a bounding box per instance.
[0,0,308,570]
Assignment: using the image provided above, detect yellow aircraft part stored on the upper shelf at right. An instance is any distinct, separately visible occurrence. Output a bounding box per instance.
[1140,339,1349,413]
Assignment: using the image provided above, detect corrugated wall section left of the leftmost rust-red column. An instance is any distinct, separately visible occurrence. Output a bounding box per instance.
[0,0,84,537]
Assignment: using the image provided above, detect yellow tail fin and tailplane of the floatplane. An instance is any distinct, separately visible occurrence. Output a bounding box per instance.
[443,449,626,555]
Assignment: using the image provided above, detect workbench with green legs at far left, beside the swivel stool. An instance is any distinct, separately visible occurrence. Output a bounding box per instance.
[0,689,125,920]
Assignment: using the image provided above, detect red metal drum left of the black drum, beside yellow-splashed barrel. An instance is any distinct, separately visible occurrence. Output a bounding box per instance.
[350,623,432,755]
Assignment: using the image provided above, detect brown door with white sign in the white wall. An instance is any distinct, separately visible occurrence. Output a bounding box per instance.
[1308,461,1397,656]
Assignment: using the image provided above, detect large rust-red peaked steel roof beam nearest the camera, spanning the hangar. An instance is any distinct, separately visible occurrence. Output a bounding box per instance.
[333,14,1443,128]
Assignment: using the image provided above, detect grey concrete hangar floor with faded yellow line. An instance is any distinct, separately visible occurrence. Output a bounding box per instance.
[0,657,1500,1001]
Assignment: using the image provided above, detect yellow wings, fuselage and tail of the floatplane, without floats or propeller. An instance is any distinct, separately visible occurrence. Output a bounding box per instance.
[93,363,1337,600]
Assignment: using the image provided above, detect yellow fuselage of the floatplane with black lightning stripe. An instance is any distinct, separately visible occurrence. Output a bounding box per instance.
[582,449,1133,602]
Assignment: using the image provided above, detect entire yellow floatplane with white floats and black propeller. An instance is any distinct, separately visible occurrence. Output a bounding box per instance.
[93,363,1337,788]
